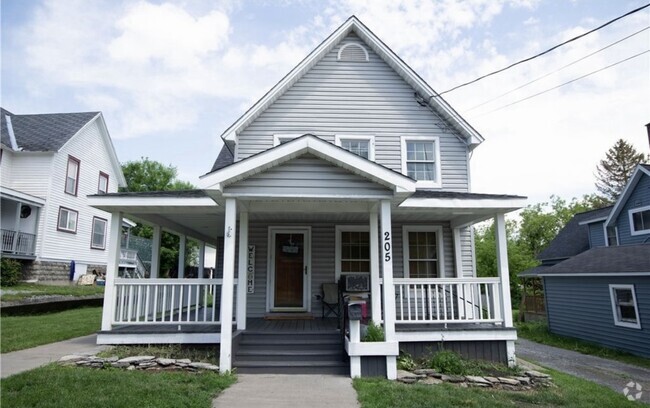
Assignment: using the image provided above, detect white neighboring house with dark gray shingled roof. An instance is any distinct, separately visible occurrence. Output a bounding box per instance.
[0,109,126,281]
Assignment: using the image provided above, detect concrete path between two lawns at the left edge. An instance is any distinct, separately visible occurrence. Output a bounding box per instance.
[0,334,107,378]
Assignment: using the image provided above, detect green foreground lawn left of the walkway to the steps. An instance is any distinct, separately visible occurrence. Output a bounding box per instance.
[0,364,235,408]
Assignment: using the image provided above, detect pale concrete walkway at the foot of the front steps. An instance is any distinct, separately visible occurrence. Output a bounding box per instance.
[212,374,359,408]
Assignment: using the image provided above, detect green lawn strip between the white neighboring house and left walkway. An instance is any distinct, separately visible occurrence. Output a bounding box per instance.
[0,307,102,353]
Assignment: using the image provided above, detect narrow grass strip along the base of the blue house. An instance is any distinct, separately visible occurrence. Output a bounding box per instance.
[517,322,650,368]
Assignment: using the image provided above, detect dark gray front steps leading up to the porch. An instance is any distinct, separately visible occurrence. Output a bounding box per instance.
[233,330,350,375]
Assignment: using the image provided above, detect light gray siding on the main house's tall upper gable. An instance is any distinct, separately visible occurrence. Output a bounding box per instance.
[235,34,469,191]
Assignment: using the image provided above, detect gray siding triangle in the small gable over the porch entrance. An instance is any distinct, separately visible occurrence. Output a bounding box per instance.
[224,154,392,197]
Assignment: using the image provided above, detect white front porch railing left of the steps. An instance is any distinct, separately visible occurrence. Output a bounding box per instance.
[113,278,237,325]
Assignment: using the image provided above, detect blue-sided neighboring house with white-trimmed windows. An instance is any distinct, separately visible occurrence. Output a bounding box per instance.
[520,164,650,357]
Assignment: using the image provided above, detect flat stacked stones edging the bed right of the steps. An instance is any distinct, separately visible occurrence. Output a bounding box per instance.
[397,368,554,391]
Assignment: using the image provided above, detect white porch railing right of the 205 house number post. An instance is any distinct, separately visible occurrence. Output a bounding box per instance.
[394,278,503,324]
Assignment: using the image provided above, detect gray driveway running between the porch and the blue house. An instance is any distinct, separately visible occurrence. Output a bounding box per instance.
[515,339,650,403]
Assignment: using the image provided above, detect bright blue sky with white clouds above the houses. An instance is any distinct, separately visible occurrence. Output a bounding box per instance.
[1,0,650,203]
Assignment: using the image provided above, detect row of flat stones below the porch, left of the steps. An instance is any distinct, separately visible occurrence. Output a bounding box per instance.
[58,354,219,372]
